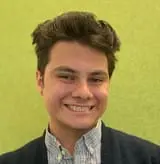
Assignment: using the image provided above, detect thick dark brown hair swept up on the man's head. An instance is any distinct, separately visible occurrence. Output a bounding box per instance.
[32,11,120,77]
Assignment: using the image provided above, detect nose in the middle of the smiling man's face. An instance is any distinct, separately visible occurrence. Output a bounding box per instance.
[72,81,93,100]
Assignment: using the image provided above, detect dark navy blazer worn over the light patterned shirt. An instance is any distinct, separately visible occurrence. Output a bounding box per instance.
[0,124,160,164]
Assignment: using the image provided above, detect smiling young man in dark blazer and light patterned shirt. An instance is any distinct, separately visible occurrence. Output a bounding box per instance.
[0,12,160,164]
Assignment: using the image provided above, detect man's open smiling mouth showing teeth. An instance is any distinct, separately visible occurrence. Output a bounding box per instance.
[64,104,94,112]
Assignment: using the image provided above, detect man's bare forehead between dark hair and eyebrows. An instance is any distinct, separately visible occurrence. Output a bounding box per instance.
[48,41,108,72]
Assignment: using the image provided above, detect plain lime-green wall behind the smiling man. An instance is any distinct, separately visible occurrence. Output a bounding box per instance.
[0,0,160,153]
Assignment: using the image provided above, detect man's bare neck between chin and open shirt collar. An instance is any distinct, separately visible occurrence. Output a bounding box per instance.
[49,122,94,155]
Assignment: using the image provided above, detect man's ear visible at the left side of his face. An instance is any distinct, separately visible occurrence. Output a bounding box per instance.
[36,70,44,96]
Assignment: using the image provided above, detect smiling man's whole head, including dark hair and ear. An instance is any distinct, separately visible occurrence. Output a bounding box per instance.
[32,12,120,133]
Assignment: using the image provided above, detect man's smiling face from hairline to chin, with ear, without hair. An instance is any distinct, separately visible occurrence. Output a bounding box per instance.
[37,41,109,130]
